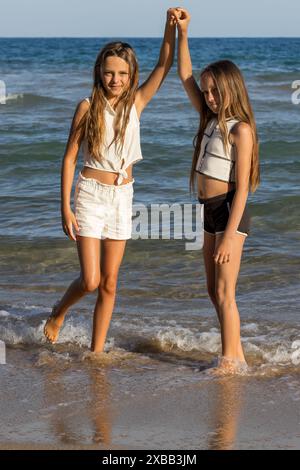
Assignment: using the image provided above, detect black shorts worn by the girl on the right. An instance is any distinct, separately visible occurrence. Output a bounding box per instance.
[199,189,250,236]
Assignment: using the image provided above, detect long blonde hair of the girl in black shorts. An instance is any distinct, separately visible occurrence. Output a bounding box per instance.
[190,60,260,192]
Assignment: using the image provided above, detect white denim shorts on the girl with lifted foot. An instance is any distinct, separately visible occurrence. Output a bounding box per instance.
[74,173,134,240]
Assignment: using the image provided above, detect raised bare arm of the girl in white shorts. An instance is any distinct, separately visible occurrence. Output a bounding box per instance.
[135,8,176,116]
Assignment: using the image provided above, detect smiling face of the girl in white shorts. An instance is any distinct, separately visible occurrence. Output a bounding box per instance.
[101,56,130,99]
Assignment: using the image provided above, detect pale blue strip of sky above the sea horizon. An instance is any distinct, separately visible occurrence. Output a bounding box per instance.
[0,0,300,37]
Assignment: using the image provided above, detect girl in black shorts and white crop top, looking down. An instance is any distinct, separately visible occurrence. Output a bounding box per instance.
[172,8,259,374]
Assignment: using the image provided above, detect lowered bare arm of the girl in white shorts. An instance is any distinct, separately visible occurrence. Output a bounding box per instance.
[61,101,89,241]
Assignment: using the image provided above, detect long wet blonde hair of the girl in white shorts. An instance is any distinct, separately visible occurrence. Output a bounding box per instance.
[78,42,138,161]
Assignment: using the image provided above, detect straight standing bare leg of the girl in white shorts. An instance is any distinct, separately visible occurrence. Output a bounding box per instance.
[91,239,126,352]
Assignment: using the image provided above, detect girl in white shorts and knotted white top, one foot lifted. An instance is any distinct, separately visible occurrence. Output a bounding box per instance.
[44,11,176,352]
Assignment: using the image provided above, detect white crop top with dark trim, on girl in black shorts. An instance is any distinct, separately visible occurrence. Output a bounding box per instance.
[195,119,239,183]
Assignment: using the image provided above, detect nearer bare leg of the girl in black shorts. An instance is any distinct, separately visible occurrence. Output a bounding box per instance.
[215,233,245,362]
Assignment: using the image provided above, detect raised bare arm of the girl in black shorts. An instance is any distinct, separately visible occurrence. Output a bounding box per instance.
[173,8,201,113]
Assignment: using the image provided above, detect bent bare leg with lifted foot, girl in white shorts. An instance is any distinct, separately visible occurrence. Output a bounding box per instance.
[44,236,100,343]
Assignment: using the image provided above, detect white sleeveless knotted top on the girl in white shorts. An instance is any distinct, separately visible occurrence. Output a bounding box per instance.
[82,98,143,185]
